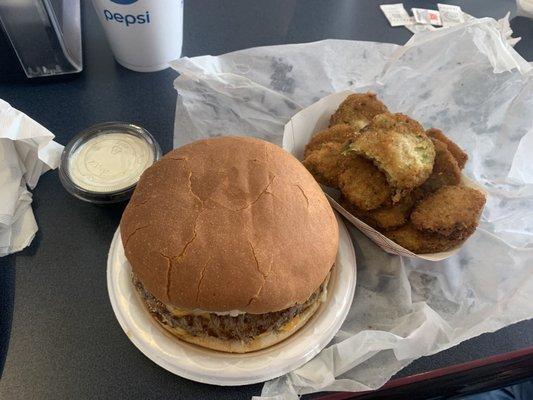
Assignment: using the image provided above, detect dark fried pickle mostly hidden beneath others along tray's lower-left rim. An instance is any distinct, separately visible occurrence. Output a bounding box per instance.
[339,195,415,230]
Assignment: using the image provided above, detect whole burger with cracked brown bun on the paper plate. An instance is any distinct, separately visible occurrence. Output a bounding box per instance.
[120,137,339,353]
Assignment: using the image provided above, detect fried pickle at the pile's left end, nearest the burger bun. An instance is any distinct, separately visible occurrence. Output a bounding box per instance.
[303,142,347,188]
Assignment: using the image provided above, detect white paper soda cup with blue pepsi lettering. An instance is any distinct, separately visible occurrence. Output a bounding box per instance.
[93,0,183,72]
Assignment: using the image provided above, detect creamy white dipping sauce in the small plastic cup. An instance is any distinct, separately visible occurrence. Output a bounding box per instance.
[68,132,154,192]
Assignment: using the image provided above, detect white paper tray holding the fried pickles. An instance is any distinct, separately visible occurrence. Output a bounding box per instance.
[283,90,485,261]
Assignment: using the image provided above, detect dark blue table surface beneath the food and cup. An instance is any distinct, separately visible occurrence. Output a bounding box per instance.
[0,0,533,400]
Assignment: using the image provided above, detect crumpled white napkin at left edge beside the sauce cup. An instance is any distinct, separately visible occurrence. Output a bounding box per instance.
[0,99,63,257]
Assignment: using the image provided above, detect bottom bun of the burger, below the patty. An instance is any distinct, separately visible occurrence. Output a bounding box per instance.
[154,299,321,353]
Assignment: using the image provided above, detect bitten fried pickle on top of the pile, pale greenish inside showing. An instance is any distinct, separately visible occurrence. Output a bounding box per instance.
[344,113,435,195]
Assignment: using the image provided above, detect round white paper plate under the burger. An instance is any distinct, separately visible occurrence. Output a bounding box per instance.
[107,214,356,385]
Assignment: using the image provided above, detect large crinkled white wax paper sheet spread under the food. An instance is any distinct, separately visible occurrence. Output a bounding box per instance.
[170,19,533,399]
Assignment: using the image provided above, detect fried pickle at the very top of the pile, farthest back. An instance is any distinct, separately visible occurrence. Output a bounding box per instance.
[329,93,389,130]
